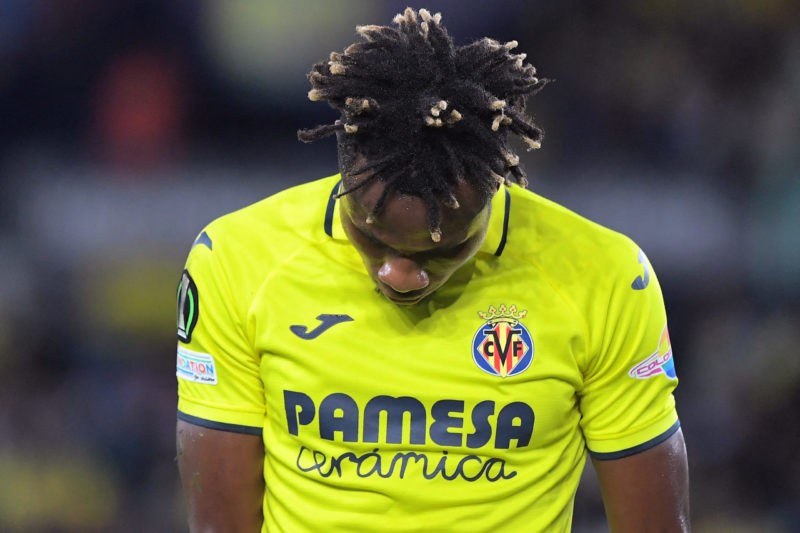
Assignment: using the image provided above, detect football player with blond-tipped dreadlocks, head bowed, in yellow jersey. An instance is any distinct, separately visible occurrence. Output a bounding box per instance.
[177,9,688,532]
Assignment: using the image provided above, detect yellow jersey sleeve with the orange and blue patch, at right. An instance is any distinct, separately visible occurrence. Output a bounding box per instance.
[580,239,679,459]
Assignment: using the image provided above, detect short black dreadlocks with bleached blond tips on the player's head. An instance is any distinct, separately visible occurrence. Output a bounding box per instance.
[297,8,550,241]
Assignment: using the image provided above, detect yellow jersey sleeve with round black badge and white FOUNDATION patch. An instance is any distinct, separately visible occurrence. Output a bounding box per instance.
[177,229,265,435]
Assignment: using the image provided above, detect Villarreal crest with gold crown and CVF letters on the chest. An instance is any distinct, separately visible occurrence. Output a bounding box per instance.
[472,305,533,378]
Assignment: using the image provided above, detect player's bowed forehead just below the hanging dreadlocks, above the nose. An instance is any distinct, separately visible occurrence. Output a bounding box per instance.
[342,176,489,250]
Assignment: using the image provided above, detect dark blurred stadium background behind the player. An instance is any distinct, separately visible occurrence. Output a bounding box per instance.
[0,0,800,532]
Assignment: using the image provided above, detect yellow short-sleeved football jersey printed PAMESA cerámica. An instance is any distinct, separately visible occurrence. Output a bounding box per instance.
[177,176,679,532]
